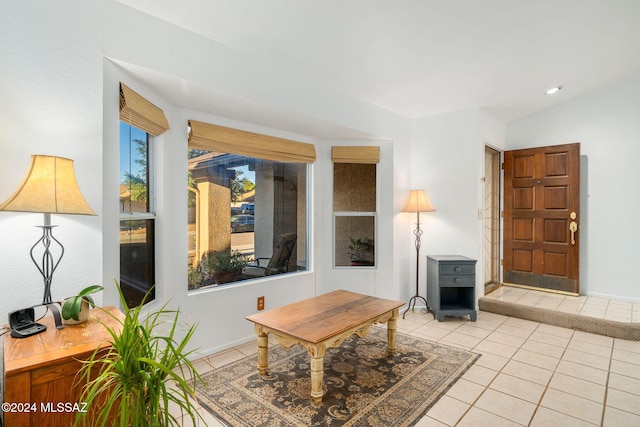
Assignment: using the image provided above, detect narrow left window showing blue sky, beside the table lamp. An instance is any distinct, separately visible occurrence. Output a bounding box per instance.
[120,122,155,307]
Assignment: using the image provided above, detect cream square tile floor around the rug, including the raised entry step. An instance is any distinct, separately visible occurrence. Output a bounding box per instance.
[188,287,640,427]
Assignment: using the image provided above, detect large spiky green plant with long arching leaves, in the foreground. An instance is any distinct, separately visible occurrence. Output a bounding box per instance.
[74,282,206,427]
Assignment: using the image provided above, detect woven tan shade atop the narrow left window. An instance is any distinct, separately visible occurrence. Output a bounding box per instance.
[120,82,169,136]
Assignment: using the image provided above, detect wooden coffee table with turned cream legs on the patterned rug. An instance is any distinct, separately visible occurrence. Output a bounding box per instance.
[247,290,404,403]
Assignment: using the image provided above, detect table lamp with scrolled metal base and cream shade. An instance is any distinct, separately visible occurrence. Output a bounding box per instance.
[0,154,96,313]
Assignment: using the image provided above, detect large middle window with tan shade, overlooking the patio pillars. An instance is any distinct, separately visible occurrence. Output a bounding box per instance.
[187,121,315,289]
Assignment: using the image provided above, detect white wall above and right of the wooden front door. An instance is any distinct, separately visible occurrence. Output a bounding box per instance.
[507,76,640,301]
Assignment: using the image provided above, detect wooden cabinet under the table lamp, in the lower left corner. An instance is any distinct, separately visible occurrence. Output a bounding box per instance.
[4,307,123,427]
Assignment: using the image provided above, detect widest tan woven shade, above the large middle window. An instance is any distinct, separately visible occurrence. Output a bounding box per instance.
[189,120,316,163]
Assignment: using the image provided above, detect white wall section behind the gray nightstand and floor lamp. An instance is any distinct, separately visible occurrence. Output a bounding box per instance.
[402,110,504,306]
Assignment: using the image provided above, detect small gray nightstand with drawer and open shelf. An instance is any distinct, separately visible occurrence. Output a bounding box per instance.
[427,255,477,322]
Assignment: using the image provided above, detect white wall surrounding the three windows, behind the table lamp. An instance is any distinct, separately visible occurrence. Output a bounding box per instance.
[0,0,410,362]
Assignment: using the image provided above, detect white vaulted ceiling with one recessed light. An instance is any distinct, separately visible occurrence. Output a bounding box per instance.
[118,0,640,123]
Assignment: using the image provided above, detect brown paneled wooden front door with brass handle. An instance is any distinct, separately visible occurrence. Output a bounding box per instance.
[503,143,580,294]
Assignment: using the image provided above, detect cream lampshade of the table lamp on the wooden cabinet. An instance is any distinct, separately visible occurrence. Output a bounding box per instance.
[0,154,96,215]
